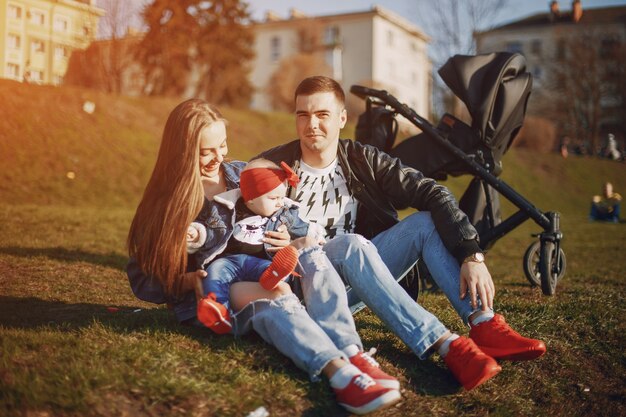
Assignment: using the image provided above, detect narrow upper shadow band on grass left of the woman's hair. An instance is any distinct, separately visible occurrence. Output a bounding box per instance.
[0,246,128,271]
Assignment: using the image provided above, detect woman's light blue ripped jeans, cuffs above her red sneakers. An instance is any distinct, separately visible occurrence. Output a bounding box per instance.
[224,247,363,380]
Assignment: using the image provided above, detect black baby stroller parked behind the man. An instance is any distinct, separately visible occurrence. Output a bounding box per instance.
[350,52,566,296]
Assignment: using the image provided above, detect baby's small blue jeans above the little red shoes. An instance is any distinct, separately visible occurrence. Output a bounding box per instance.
[202,254,272,308]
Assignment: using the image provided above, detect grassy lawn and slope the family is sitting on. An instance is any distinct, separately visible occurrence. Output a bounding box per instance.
[0,80,626,416]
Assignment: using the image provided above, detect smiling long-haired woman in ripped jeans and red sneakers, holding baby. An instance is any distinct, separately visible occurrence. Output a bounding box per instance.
[126,99,400,414]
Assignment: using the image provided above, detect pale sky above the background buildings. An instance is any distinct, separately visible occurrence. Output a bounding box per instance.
[248,0,626,29]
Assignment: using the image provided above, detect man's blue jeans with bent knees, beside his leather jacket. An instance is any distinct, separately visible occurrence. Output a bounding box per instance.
[324,212,476,359]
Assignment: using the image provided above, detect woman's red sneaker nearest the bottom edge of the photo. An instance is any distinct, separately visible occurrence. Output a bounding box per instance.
[334,374,400,414]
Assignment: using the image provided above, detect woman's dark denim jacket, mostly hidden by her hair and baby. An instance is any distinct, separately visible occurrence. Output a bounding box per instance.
[126,161,246,322]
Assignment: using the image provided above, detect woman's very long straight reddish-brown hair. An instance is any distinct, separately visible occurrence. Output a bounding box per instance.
[127,99,225,294]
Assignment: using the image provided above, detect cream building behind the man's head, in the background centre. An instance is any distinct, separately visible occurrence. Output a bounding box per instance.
[251,6,432,118]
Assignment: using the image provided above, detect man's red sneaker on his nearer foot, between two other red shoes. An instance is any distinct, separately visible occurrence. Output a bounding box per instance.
[443,336,502,391]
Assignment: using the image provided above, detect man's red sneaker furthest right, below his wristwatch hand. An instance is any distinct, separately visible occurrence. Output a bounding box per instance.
[469,314,546,361]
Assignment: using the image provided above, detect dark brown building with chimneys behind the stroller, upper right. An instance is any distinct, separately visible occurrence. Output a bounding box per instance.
[475,0,626,147]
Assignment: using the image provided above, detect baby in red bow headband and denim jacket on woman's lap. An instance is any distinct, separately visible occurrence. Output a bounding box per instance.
[187,159,324,333]
